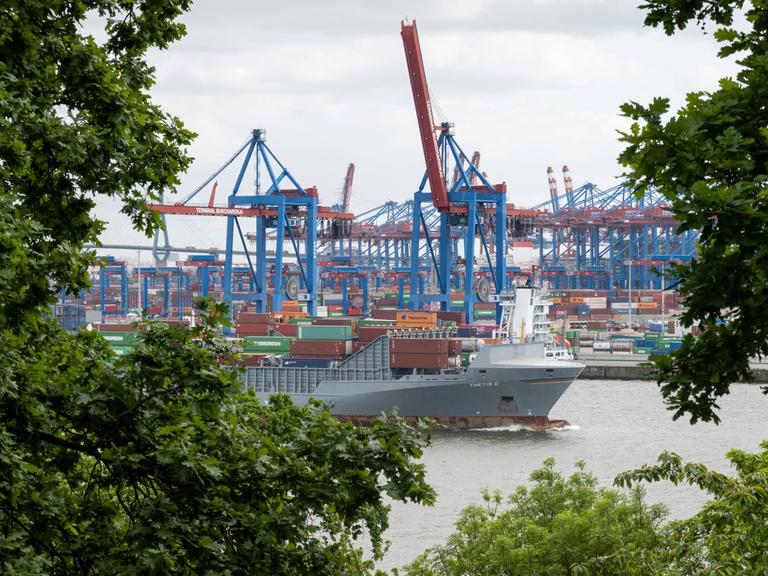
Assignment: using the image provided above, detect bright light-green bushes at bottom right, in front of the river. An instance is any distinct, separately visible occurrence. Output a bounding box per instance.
[404,450,768,576]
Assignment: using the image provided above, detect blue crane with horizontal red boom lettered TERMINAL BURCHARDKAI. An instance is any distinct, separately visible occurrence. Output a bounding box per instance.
[151,129,353,322]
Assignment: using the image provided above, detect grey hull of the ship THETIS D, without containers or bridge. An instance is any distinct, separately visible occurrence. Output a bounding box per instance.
[247,344,584,429]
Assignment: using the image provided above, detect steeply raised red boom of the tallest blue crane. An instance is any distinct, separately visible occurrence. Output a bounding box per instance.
[400,20,449,212]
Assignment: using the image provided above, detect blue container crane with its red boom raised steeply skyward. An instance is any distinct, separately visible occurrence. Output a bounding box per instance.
[400,22,508,323]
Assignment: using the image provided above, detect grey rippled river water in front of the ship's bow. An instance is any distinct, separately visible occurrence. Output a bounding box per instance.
[379,380,768,569]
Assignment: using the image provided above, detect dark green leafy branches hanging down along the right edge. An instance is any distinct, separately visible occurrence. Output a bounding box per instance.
[620,0,768,422]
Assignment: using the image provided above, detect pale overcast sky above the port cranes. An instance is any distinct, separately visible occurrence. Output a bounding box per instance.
[93,0,733,254]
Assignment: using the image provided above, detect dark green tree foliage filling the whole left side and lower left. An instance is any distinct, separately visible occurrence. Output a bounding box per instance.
[0,0,434,575]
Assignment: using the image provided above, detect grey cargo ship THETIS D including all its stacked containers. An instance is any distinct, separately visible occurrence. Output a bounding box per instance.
[93,289,584,430]
